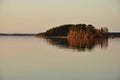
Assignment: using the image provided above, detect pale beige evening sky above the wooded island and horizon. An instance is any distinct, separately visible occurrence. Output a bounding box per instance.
[0,0,120,33]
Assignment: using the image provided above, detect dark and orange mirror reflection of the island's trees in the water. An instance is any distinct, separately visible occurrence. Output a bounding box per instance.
[46,38,108,51]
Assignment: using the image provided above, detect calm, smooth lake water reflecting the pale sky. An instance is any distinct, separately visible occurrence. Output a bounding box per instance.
[0,36,120,80]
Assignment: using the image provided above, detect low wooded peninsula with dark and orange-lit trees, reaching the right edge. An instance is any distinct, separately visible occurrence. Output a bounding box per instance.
[36,24,120,39]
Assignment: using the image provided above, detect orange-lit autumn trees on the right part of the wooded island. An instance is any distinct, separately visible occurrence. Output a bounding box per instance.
[67,24,108,39]
